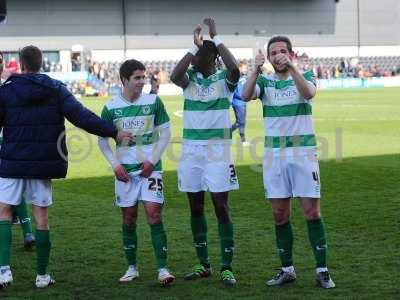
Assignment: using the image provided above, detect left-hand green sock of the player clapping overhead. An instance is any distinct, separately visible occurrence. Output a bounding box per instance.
[190,215,209,265]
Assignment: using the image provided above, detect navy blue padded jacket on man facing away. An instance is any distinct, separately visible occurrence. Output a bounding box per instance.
[0,74,117,179]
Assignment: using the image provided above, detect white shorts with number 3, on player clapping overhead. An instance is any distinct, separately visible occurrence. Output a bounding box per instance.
[178,144,239,193]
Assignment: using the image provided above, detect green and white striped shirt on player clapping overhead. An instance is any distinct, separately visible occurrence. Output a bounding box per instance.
[183,69,236,145]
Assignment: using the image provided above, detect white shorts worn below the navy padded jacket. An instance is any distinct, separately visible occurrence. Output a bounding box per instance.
[0,178,53,207]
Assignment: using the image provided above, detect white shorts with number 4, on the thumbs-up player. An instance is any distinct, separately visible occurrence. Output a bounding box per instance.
[263,154,321,199]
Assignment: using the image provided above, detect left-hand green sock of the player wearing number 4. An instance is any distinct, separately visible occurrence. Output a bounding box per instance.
[275,222,293,267]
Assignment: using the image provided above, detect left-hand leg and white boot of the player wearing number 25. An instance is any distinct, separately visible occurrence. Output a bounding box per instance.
[119,202,139,282]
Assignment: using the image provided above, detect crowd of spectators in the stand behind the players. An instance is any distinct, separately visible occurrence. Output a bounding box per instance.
[5,53,400,95]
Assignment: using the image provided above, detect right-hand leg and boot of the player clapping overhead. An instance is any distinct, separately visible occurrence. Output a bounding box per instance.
[211,192,236,285]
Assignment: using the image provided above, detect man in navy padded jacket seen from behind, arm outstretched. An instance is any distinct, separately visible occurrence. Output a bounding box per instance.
[0,46,131,288]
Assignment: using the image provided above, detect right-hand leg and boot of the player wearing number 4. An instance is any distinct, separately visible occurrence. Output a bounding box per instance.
[300,197,335,288]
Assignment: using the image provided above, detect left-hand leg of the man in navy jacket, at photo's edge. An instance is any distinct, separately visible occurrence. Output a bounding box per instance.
[0,203,13,289]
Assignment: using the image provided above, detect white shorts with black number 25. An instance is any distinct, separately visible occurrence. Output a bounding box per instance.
[115,171,164,207]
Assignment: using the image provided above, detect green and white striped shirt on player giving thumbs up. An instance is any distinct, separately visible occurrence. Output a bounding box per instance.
[256,71,316,151]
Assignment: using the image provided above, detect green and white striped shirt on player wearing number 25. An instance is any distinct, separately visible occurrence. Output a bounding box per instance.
[101,94,170,173]
